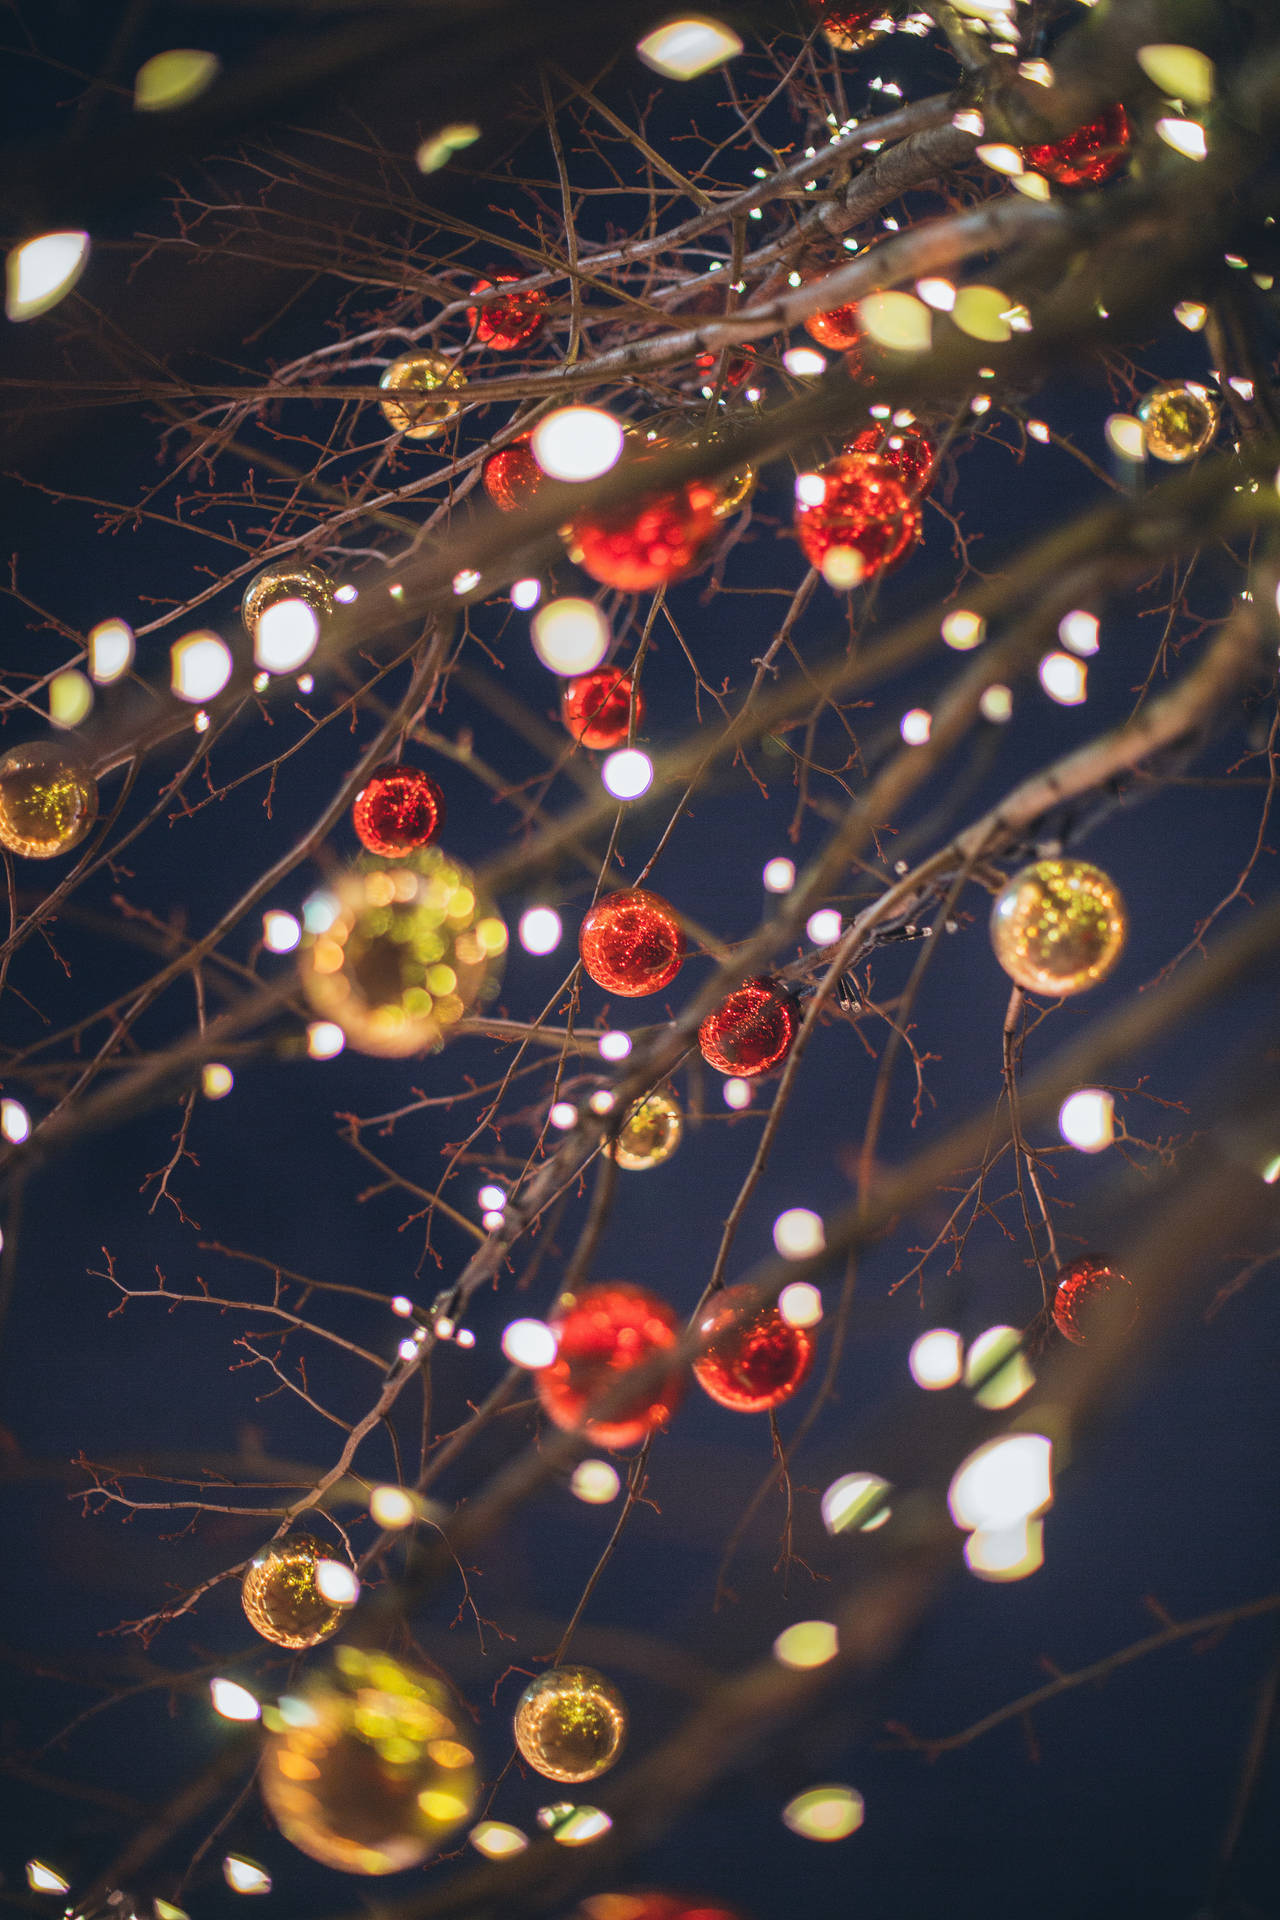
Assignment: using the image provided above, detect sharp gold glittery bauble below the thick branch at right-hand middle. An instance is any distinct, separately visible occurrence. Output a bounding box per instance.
[990,860,1128,995]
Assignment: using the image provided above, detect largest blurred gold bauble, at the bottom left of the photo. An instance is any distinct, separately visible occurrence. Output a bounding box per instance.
[261,1645,480,1874]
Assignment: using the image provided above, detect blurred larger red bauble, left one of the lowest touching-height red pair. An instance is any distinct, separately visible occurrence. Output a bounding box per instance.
[533,1281,683,1446]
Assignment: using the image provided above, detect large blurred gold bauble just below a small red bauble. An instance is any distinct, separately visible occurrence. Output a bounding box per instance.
[301,847,507,1058]
